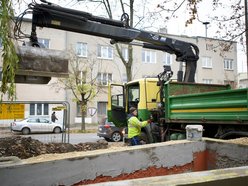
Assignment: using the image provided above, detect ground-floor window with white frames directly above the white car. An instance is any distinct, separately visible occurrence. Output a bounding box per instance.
[29,103,49,116]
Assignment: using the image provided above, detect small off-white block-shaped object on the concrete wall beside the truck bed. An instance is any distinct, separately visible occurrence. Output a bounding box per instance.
[186,125,203,140]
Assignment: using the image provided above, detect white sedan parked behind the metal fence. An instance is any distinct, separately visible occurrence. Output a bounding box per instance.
[10,118,63,135]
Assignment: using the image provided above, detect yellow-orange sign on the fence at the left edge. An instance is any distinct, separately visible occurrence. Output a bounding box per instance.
[0,103,25,119]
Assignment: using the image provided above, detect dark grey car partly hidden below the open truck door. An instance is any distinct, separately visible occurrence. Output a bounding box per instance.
[97,118,123,142]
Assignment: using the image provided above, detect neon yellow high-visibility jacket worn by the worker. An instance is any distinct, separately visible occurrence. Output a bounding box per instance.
[128,116,148,138]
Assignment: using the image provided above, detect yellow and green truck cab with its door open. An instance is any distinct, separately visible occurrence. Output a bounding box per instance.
[108,78,160,127]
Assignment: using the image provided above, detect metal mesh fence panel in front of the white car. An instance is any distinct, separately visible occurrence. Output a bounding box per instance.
[0,101,70,143]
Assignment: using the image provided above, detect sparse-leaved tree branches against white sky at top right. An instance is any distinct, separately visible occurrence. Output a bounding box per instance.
[157,0,248,72]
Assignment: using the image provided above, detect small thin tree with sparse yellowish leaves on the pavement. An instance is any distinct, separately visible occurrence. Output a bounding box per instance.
[52,52,100,130]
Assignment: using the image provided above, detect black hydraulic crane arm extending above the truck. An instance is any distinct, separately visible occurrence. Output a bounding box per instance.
[26,1,199,82]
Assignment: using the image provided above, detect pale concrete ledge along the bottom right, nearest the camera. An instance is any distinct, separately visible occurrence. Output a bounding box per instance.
[94,166,248,186]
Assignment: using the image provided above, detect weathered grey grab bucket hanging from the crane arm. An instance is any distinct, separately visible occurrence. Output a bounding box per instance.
[15,46,69,84]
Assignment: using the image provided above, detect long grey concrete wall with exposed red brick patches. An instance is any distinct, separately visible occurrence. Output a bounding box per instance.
[0,140,248,186]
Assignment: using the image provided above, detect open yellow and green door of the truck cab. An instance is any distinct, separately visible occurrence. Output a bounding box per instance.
[108,84,127,127]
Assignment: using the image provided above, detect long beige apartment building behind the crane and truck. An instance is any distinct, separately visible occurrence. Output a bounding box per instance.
[0,20,237,124]
